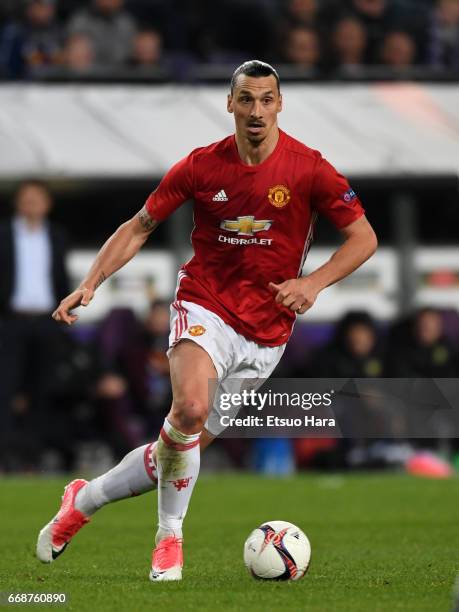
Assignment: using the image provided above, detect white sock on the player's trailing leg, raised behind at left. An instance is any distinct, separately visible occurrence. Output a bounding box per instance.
[75,442,158,516]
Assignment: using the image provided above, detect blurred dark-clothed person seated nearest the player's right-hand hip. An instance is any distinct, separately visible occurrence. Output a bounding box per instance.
[308,312,383,378]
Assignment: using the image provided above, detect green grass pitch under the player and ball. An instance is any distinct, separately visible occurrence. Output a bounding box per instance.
[0,475,459,612]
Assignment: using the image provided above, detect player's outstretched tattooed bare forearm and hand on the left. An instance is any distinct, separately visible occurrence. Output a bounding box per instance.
[53,206,158,325]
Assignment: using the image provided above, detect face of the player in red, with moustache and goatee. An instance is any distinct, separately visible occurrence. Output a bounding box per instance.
[228,74,282,145]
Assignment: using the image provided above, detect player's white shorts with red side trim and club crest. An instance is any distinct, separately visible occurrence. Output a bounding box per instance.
[167,301,285,436]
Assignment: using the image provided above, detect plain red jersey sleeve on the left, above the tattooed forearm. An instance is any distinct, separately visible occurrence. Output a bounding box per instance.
[145,153,194,221]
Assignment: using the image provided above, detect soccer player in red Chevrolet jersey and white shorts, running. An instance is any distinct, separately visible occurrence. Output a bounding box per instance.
[37,60,377,581]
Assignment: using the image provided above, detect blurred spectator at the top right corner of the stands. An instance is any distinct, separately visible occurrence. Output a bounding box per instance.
[427,0,459,72]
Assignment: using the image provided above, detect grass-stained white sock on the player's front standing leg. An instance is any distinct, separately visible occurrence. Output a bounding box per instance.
[156,419,200,543]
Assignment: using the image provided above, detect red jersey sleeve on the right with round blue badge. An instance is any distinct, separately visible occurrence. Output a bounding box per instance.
[311,156,365,229]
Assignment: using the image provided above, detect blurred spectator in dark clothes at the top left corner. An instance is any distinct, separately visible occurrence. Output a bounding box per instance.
[0,0,62,79]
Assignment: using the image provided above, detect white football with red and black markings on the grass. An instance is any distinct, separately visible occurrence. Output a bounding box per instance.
[244,521,311,580]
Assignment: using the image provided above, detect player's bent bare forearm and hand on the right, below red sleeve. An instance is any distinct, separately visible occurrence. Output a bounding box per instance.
[269,216,378,314]
